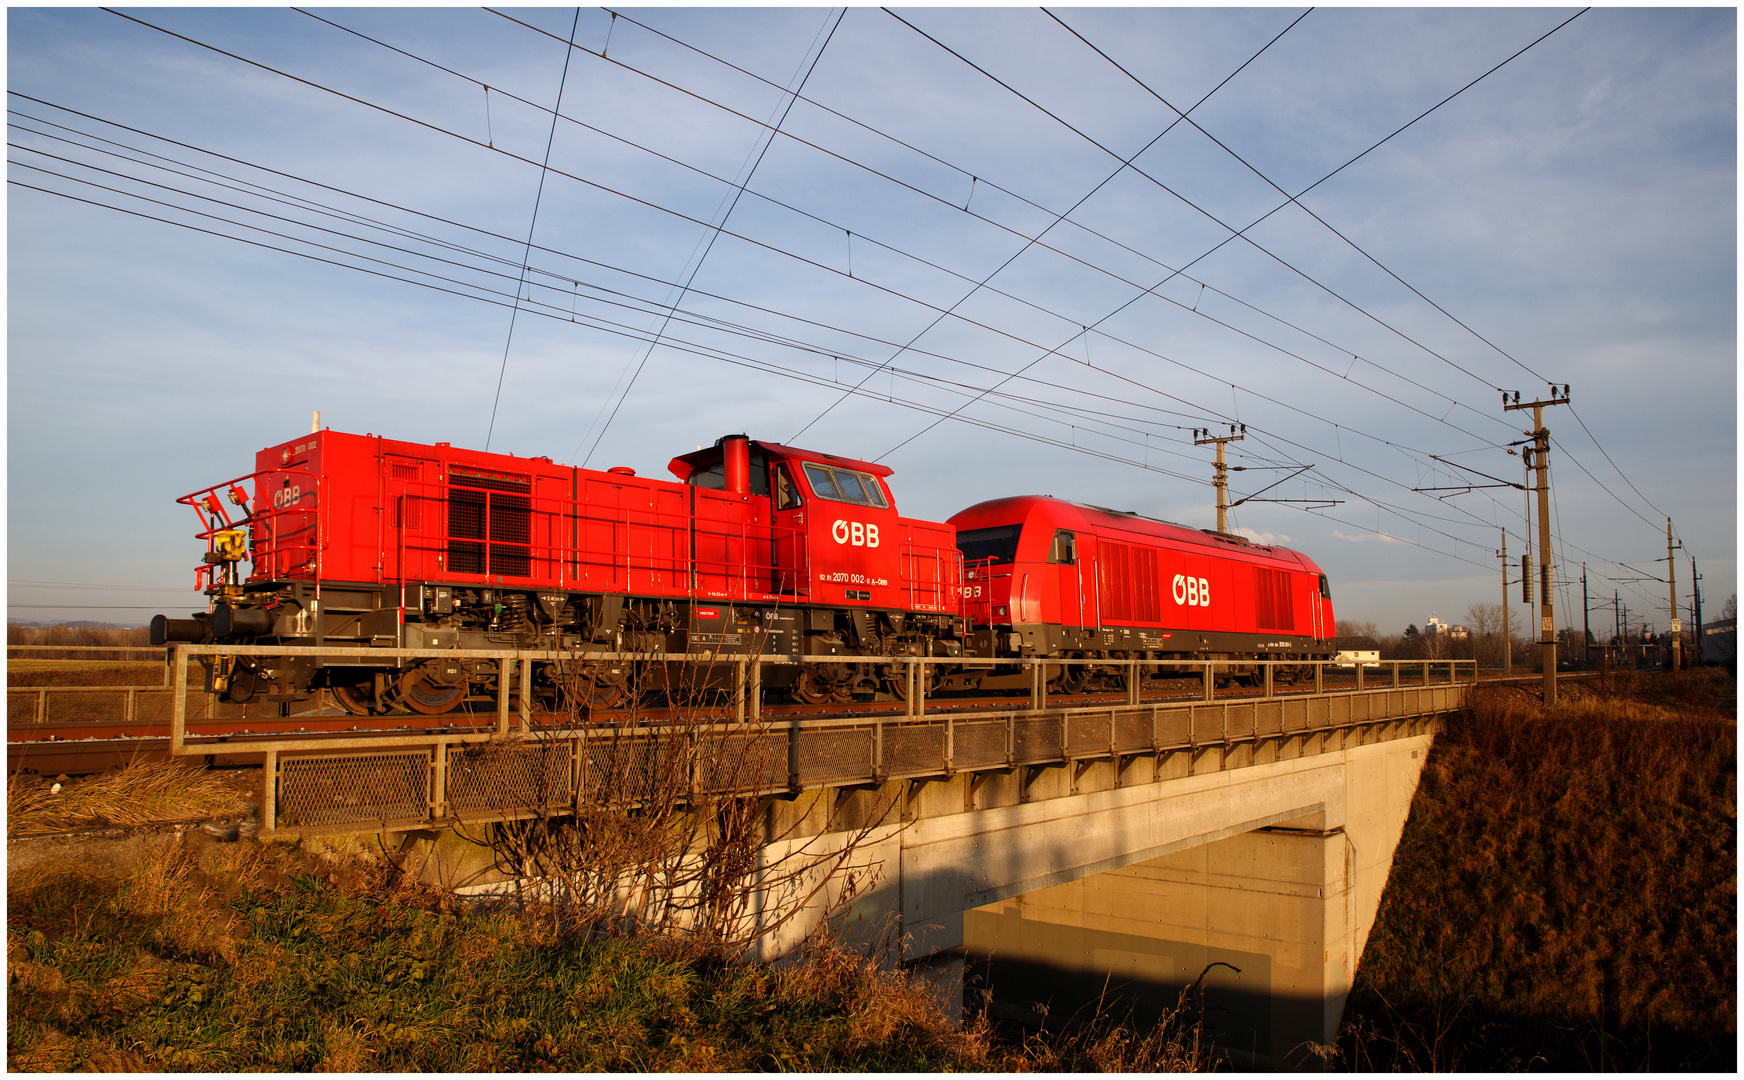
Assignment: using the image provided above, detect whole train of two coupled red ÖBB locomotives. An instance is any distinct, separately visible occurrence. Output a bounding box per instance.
[152,431,1332,714]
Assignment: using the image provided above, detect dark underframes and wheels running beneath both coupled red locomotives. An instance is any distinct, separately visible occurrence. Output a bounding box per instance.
[170,579,1331,714]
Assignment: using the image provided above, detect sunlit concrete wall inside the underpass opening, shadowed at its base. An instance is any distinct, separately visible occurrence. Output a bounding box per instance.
[963,813,1355,1068]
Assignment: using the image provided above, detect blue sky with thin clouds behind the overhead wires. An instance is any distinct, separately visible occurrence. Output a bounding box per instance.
[7,7,1737,632]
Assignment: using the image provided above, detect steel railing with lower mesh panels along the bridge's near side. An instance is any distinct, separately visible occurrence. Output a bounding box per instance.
[171,646,1475,834]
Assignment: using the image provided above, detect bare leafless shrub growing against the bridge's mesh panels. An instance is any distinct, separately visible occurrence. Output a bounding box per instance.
[456,635,893,953]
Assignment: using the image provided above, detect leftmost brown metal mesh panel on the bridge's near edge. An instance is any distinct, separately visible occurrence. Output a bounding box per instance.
[276,750,431,827]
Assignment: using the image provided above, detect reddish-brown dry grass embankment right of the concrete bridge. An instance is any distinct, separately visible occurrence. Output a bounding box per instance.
[1341,672,1737,1070]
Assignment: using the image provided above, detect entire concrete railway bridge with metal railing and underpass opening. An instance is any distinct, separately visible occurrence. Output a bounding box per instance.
[160,646,1475,1068]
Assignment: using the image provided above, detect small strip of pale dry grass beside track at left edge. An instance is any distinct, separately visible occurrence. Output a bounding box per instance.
[7,759,256,836]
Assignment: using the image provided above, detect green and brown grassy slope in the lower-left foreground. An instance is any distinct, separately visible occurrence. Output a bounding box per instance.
[7,827,1220,1073]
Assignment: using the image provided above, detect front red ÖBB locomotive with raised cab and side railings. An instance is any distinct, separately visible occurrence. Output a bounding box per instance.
[152,431,963,714]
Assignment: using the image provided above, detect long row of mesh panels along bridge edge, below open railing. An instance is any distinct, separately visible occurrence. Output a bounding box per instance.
[249,682,1470,837]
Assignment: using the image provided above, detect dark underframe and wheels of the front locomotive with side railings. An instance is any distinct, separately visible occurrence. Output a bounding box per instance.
[173,579,963,714]
